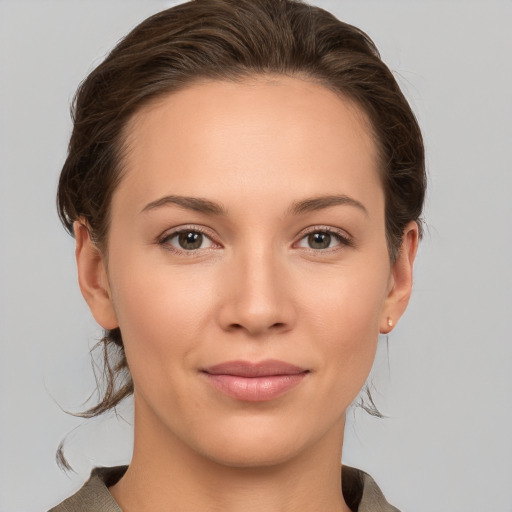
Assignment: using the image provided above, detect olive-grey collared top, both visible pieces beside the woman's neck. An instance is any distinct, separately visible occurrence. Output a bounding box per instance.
[48,466,400,512]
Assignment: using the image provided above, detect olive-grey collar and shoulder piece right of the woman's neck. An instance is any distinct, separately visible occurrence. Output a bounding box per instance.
[342,466,400,512]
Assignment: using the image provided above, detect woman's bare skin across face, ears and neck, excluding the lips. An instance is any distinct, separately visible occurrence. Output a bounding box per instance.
[75,76,418,512]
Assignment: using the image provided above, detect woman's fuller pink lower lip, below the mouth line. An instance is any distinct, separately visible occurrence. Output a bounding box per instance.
[205,372,307,402]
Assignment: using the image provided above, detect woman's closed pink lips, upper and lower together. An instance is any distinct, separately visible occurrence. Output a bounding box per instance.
[202,359,309,402]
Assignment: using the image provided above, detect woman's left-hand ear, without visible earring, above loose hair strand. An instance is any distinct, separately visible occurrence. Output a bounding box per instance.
[73,221,119,329]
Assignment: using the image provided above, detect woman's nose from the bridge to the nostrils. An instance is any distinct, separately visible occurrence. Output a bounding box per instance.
[219,248,296,337]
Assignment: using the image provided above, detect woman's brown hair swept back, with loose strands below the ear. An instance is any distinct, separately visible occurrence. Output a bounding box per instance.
[57,0,426,424]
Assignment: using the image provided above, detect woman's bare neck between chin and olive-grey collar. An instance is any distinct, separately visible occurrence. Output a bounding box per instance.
[110,400,350,512]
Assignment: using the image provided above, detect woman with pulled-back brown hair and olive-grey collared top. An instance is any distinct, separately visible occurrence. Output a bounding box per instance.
[52,0,425,512]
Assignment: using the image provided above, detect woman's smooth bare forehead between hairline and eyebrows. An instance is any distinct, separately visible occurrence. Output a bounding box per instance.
[114,76,382,217]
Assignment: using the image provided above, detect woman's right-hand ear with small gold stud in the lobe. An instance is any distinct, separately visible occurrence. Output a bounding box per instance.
[380,221,419,334]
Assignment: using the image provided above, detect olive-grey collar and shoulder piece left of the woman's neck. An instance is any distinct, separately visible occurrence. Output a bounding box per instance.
[48,466,128,512]
